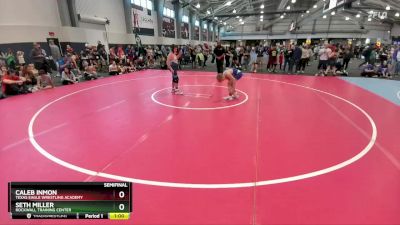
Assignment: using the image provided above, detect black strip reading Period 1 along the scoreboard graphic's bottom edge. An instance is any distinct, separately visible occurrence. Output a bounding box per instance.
[11,213,109,220]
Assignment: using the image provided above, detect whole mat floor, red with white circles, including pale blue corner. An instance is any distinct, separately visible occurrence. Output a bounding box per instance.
[0,70,400,224]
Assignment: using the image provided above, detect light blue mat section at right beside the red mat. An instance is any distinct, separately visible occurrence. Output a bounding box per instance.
[342,77,400,106]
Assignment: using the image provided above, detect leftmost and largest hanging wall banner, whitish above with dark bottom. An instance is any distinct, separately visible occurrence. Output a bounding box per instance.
[132,5,157,36]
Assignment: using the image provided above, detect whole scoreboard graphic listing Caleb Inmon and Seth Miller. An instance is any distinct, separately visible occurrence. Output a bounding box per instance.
[8,182,132,220]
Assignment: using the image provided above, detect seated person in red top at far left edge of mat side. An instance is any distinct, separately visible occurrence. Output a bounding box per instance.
[1,67,29,95]
